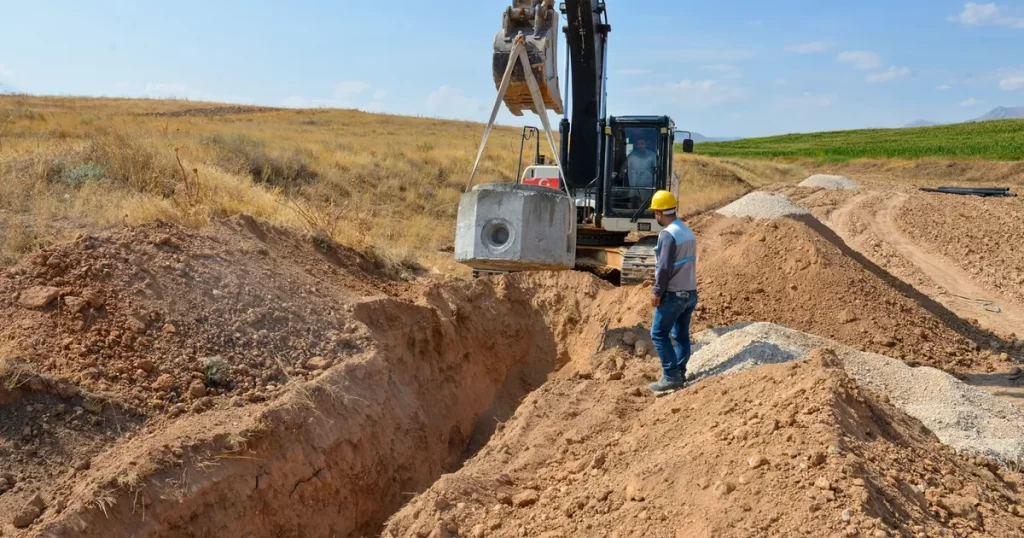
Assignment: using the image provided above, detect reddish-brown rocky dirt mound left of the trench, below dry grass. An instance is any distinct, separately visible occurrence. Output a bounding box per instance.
[0,218,400,413]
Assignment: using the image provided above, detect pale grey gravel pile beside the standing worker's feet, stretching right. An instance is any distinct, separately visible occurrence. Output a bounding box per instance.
[689,323,1024,462]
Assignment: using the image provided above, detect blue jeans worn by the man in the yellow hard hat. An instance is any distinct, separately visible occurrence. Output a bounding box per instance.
[650,291,697,381]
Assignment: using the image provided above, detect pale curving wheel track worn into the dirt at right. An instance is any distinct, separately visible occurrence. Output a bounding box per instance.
[828,193,1024,334]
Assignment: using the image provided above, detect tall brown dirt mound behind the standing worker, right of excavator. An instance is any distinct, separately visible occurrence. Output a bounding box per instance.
[693,211,987,367]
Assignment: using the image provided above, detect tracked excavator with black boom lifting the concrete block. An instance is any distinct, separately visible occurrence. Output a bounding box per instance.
[493,0,693,285]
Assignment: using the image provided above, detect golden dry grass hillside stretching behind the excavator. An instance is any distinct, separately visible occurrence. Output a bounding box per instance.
[0,95,804,272]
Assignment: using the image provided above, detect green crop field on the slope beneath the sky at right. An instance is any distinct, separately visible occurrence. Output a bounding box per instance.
[677,120,1024,162]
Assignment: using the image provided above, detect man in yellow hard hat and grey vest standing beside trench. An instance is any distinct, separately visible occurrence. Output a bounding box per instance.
[648,191,697,392]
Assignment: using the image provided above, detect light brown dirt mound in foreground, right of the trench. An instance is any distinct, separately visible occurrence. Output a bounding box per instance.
[383,349,1024,538]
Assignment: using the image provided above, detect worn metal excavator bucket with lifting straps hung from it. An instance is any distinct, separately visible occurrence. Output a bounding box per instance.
[492,0,563,116]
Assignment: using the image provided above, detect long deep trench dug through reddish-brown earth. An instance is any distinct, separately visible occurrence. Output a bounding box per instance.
[19,264,617,538]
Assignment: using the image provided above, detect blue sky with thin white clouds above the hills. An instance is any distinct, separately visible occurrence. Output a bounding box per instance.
[0,0,1024,136]
